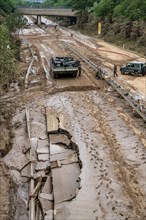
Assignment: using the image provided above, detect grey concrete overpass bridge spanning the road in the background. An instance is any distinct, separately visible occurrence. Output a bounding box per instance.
[16,7,76,24]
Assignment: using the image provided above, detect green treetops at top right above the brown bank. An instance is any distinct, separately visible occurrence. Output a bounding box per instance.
[45,0,146,20]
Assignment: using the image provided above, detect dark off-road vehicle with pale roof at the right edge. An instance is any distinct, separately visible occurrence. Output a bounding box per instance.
[120,61,146,76]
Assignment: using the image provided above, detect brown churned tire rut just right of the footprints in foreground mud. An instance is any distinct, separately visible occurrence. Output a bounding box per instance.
[82,93,145,218]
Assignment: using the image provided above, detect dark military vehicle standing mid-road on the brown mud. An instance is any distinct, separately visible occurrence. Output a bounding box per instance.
[50,57,81,78]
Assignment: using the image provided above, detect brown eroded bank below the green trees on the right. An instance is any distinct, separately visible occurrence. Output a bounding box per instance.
[74,13,146,56]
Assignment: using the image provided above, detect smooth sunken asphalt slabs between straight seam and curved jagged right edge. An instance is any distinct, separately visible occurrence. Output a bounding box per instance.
[45,107,82,220]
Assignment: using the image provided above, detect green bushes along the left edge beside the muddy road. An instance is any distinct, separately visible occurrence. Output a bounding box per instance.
[0,0,24,87]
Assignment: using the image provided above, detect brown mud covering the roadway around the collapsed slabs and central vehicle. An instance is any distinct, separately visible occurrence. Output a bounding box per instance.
[1,15,146,220]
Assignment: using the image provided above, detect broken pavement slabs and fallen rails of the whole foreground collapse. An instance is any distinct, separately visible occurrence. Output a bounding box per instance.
[23,108,81,220]
